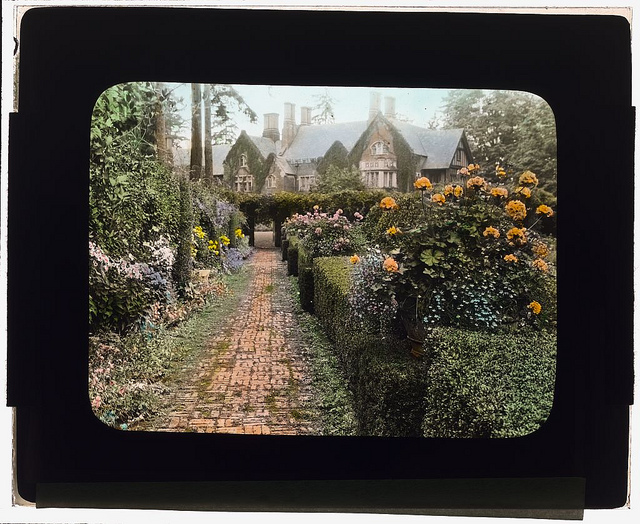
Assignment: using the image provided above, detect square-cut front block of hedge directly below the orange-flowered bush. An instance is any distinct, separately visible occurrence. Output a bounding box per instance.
[422,328,556,438]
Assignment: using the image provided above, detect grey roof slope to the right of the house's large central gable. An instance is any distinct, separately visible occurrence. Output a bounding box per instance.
[392,120,464,169]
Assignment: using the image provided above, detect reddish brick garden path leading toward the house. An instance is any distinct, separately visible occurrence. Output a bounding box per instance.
[145,233,319,435]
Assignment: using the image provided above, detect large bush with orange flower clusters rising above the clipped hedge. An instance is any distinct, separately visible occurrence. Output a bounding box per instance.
[353,164,555,329]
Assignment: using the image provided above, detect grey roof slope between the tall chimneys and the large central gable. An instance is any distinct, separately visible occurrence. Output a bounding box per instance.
[283,120,368,162]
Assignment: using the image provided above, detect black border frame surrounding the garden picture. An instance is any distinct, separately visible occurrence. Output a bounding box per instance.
[8,7,635,512]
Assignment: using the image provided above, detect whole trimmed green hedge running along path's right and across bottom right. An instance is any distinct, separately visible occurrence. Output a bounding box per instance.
[312,257,556,438]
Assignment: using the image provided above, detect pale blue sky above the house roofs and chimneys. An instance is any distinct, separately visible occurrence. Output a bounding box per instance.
[166,84,447,142]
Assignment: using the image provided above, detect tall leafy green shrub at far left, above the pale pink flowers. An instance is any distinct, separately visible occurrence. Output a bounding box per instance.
[89,83,178,258]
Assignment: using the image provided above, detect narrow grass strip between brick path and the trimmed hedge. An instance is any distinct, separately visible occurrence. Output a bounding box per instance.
[285,276,356,436]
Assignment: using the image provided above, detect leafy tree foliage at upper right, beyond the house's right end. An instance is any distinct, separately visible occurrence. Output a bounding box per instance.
[443,89,557,193]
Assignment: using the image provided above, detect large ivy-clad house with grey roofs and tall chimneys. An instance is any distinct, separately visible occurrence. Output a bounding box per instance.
[218,93,473,194]
